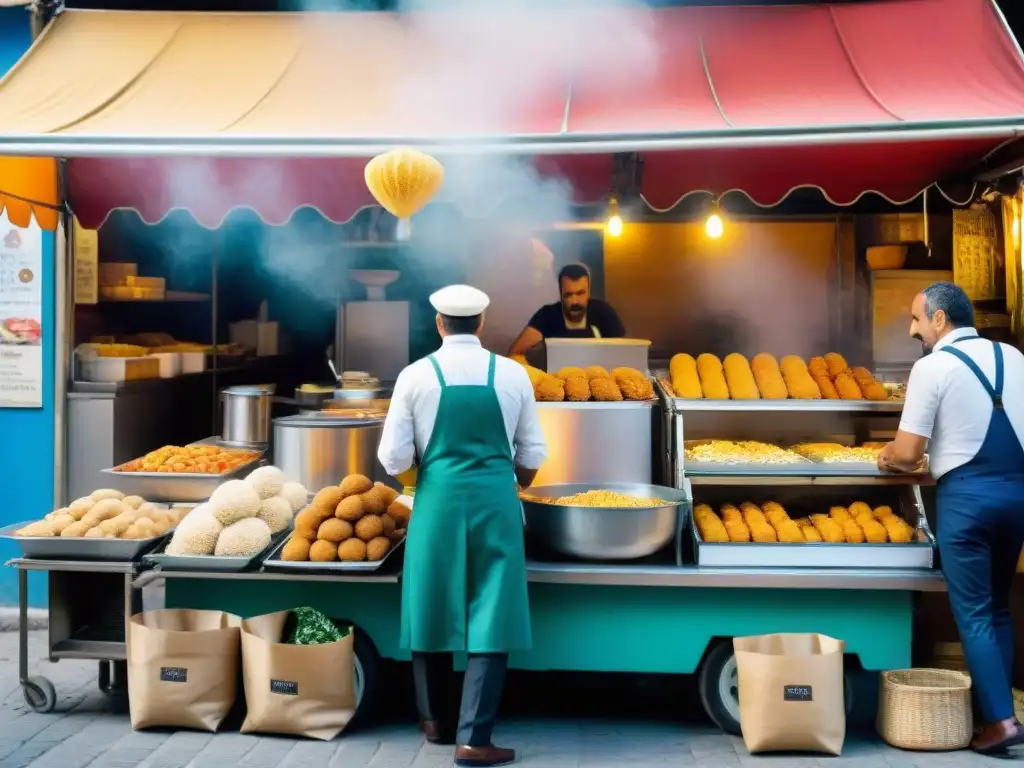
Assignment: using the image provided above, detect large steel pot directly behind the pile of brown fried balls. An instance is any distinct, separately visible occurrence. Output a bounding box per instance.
[273,412,384,492]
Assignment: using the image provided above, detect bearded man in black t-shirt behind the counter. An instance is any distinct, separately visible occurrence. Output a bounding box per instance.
[509,264,626,355]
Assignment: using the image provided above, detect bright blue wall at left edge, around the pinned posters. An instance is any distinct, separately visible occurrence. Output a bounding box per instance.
[0,8,56,606]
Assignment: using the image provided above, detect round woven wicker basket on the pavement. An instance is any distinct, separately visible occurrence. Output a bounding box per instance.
[878,670,974,752]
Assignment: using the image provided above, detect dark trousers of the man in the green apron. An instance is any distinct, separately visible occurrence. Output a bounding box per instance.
[413,653,509,746]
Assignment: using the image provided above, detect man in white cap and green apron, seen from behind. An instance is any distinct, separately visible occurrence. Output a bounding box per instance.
[377,286,547,766]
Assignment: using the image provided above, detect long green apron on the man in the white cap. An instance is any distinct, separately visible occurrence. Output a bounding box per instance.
[401,354,531,653]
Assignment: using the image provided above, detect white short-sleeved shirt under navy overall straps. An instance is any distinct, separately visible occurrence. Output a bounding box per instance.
[899,328,1024,478]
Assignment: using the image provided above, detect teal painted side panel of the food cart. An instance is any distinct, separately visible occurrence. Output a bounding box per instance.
[167,578,913,674]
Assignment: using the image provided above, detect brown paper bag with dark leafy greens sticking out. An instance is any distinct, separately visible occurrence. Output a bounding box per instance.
[242,610,355,741]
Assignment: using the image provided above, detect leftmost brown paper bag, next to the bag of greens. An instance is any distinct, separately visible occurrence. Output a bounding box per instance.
[128,610,241,731]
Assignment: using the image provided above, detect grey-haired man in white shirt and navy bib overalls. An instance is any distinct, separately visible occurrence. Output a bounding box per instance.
[879,283,1024,753]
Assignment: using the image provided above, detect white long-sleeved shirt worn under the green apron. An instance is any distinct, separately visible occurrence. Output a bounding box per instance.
[377,335,548,475]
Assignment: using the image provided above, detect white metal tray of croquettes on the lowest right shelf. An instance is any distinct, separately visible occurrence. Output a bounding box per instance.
[690,524,935,568]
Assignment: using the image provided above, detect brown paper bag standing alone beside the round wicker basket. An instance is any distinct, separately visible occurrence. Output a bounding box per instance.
[732,635,846,755]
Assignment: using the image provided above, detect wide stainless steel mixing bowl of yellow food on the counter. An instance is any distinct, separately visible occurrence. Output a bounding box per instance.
[522,483,686,560]
